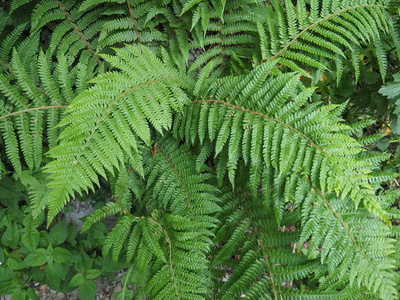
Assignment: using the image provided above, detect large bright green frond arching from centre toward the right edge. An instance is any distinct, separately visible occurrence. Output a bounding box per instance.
[176,62,384,217]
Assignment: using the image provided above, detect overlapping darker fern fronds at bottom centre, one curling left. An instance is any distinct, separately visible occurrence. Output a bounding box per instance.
[84,136,220,299]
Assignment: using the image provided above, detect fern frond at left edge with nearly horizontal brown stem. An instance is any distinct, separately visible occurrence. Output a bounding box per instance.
[0,46,93,175]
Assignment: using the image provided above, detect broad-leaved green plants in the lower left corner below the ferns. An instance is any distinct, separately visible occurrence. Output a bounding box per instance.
[0,177,122,299]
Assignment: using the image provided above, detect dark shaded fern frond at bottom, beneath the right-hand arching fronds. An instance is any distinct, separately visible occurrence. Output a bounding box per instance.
[209,191,320,299]
